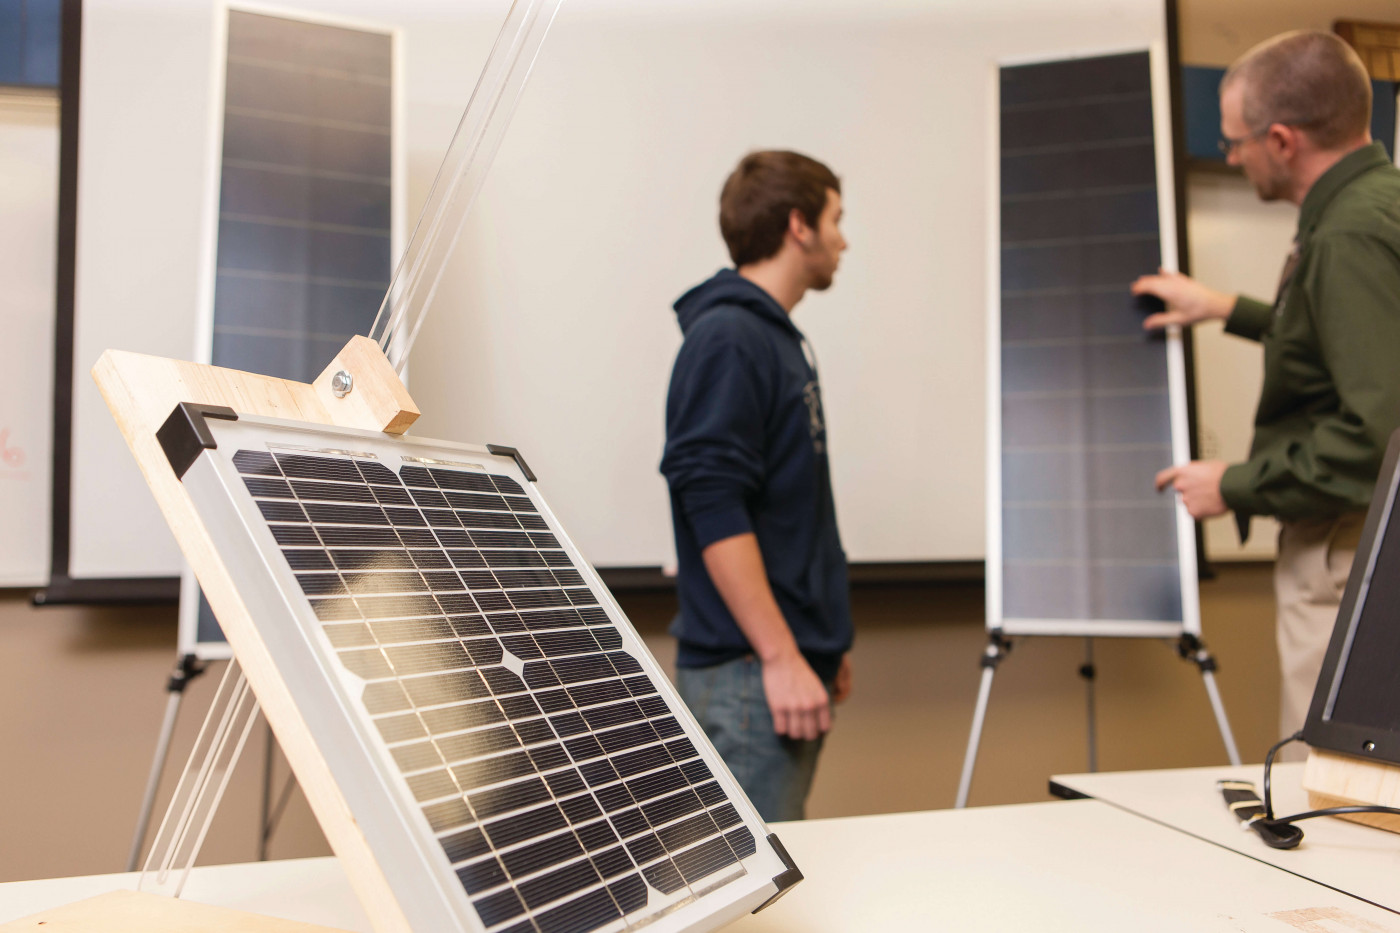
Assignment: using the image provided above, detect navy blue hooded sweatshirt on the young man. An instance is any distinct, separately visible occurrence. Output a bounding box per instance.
[661,269,851,681]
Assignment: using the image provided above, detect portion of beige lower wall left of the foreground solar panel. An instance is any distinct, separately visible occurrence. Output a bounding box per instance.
[0,590,326,881]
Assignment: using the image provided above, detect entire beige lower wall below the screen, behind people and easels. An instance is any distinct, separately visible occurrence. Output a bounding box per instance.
[0,566,1277,881]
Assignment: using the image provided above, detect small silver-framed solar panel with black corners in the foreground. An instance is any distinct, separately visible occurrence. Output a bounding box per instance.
[161,406,801,933]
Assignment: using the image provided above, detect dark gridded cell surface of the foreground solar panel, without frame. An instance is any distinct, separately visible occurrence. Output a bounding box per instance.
[234,450,753,932]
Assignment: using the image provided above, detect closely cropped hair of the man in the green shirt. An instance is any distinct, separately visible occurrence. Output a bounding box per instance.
[1221,32,1371,148]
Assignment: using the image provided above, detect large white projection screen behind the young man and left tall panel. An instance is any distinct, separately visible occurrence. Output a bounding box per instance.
[71,0,1165,577]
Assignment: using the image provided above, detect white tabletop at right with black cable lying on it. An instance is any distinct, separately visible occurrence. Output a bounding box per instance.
[1050,762,1400,913]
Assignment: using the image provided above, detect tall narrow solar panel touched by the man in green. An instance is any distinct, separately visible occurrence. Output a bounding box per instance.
[987,50,1198,636]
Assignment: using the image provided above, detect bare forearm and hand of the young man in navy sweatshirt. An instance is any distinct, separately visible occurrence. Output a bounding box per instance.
[700,532,832,738]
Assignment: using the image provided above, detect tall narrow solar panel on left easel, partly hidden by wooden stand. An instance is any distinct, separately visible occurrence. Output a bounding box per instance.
[181,8,396,657]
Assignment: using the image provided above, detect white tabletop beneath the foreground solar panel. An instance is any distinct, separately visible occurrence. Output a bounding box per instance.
[0,800,1400,933]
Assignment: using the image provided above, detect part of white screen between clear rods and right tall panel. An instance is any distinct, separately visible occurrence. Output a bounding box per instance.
[410,0,1165,565]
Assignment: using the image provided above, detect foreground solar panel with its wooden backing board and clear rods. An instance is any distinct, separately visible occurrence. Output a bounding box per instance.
[107,0,801,918]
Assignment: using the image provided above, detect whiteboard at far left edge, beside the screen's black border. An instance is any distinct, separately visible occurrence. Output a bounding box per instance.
[0,90,59,587]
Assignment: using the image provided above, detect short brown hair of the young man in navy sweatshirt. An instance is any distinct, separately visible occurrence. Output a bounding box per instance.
[720,150,841,266]
